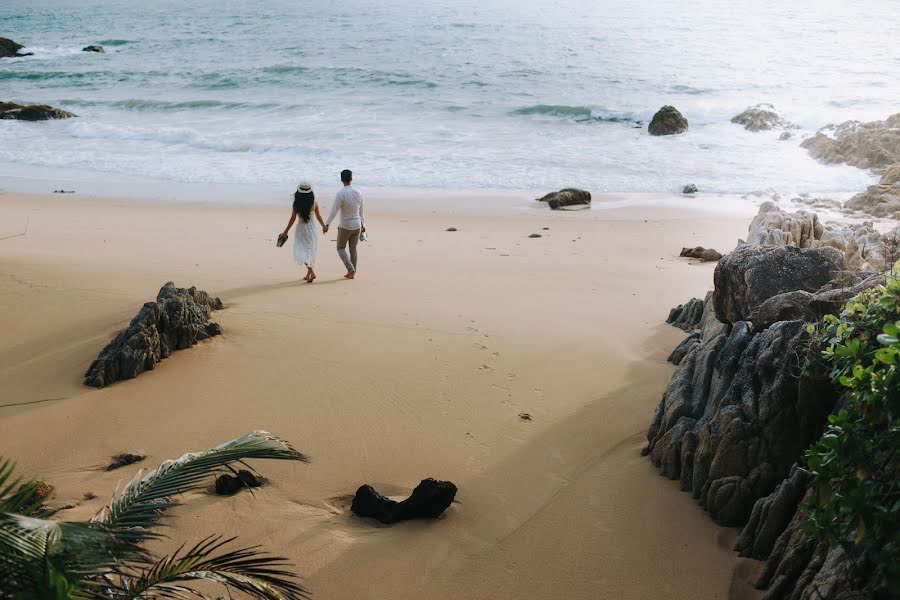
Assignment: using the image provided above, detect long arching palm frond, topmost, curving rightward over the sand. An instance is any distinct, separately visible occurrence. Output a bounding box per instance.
[94,431,309,542]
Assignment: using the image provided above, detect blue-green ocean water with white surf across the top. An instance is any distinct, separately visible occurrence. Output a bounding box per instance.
[0,0,900,193]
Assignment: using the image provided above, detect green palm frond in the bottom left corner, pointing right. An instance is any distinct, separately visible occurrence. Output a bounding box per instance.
[0,513,134,597]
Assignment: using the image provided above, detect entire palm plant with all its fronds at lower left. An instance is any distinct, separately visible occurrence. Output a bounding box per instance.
[0,431,309,600]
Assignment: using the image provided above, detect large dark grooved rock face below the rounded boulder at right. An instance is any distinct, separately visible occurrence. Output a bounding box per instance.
[644,300,834,525]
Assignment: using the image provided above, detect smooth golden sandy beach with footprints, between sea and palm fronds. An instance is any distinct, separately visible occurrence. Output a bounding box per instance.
[0,190,756,599]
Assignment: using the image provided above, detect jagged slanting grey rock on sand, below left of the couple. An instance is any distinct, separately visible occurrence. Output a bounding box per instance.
[84,281,222,388]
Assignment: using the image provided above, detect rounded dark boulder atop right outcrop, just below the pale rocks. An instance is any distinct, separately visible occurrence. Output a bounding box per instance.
[712,244,845,323]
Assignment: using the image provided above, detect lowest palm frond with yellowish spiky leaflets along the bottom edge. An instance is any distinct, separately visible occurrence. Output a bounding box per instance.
[102,536,310,600]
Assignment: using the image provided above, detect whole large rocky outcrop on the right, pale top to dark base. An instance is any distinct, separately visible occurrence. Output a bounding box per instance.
[643,206,884,600]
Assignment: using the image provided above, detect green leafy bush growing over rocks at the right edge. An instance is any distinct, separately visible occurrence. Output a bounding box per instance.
[803,277,900,591]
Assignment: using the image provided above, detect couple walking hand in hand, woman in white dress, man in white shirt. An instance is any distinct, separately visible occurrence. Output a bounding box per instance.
[278,169,366,283]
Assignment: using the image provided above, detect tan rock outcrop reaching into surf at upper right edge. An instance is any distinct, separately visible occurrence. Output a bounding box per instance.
[800,113,900,171]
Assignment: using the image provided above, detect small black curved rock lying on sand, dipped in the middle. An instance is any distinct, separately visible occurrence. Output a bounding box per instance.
[350,478,456,525]
